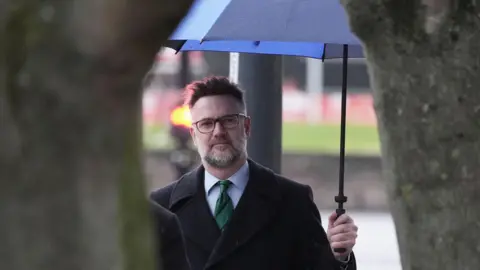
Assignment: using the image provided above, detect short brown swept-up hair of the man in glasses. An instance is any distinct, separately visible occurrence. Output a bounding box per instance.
[184,76,245,109]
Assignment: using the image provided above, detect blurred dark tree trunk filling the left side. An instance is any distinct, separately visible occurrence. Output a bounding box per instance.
[0,0,192,270]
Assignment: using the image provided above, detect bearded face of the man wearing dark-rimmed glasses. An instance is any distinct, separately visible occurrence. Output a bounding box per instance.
[190,95,250,168]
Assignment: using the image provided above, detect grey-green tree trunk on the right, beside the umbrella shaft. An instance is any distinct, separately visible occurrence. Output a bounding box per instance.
[343,0,480,270]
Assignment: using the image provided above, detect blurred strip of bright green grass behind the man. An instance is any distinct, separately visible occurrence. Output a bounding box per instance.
[144,123,379,155]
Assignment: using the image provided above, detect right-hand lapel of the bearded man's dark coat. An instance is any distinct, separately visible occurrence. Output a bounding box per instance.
[205,160,281,269]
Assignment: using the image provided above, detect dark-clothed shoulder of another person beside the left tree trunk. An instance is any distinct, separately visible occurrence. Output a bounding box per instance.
[150,201,190,270]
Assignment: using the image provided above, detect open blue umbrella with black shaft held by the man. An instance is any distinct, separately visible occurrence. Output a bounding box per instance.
[167,0,363,249]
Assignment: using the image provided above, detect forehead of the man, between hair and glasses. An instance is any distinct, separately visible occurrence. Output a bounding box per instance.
[190,95,242,121]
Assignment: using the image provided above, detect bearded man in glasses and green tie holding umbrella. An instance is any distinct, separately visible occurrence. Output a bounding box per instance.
[151,77,357,270]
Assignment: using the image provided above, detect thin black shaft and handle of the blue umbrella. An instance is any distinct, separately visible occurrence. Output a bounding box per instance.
[334,45,348,253]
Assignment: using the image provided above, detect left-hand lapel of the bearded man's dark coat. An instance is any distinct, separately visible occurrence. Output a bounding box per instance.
[169,166,220,253]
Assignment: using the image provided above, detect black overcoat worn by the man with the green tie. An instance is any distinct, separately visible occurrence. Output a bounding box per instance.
[151,160,356,270]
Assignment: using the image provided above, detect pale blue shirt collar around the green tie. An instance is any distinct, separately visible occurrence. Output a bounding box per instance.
[205,162,249,214]
